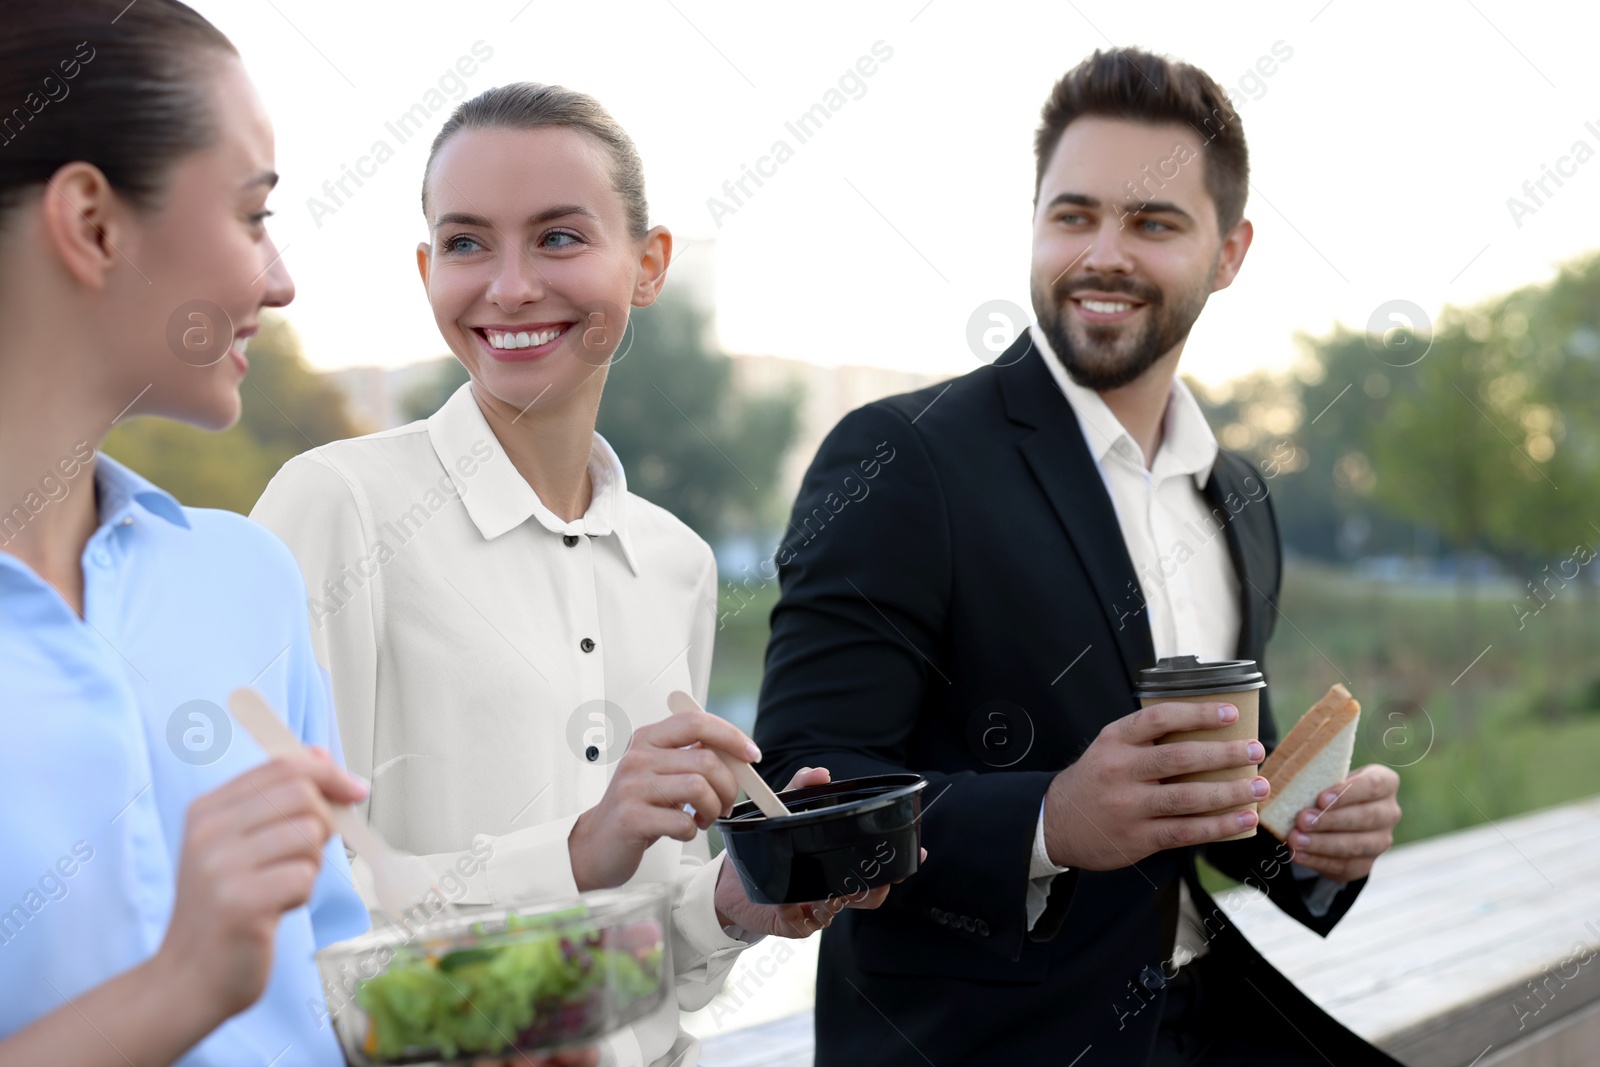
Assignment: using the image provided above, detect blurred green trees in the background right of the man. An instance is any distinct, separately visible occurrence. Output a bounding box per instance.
[1197,256,1600,573]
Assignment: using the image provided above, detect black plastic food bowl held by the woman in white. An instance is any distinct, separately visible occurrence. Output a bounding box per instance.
[717,774,928,904]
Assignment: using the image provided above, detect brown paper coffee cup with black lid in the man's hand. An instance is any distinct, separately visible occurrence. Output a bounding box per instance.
[1136,656,1267,841]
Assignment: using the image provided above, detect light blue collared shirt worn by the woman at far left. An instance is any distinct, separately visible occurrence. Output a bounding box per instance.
[0,456,368,1067]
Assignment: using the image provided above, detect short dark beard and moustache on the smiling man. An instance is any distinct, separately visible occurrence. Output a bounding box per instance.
[1030,262,1216,392]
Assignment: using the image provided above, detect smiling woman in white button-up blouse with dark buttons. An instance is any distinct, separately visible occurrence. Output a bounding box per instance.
[253,83,885,1064]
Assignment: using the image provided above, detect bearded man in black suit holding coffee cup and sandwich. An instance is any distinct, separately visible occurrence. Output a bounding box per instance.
[755,50,1400,1067]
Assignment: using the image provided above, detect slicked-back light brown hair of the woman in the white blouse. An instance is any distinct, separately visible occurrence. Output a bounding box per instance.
[422,82,650,238]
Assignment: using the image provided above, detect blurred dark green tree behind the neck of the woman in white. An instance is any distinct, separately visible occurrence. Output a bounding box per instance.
[403,290,798,542]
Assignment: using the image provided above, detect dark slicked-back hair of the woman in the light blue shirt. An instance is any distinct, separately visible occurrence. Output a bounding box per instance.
[0,0,238,222]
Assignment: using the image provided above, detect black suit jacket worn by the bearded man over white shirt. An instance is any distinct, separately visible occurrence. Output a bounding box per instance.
[755,334,1392,1067]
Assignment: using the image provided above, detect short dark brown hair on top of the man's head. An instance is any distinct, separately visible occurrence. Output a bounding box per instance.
[1034,48,1250,234]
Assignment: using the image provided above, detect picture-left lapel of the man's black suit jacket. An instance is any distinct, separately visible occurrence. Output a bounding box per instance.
[995,333,1155,685]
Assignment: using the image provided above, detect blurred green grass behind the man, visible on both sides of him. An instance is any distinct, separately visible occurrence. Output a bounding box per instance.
[710,565,1600,841]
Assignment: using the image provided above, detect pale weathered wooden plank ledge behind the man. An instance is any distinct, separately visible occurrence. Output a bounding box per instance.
[685,790,1600,1067]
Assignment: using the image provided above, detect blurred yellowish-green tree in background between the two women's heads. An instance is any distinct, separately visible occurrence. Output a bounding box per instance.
[102,314,366,514]
